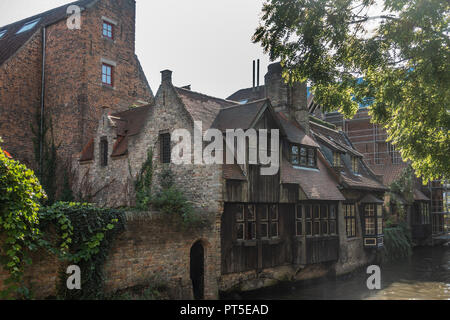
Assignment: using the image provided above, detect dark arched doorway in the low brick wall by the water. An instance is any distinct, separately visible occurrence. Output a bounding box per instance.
[191,241,205,300]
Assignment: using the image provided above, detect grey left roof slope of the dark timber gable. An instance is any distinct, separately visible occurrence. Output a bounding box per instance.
[211,99,268,131]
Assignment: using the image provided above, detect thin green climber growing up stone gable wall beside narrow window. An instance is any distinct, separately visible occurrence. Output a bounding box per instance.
[134,149,153,210]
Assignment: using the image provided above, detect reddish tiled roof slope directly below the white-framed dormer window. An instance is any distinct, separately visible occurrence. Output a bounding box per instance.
[281,158,345,201]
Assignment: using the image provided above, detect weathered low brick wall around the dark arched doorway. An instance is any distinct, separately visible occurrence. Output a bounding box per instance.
[0,212,220,299]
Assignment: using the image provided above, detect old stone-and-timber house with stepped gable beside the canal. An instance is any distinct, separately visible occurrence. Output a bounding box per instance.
[68,64,386,298]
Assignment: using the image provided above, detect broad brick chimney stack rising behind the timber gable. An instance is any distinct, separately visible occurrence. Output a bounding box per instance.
[265,62,310,134]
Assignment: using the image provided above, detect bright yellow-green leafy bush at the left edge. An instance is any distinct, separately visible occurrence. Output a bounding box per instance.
[0,144,46,298]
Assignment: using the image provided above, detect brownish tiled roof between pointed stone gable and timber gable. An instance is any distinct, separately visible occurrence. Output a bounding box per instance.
[175,88,237,130]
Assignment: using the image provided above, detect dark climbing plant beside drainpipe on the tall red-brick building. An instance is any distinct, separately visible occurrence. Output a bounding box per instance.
[31,113,58,205]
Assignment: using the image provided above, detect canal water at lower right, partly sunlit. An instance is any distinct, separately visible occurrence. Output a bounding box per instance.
[241,246,450,300]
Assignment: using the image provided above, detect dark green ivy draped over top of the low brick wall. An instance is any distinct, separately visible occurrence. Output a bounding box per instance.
[39,202,124,300]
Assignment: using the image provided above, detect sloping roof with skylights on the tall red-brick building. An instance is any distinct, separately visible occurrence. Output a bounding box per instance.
[0,0,98,65]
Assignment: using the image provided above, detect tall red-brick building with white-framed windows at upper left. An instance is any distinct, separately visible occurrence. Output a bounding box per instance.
[0,0,153,169]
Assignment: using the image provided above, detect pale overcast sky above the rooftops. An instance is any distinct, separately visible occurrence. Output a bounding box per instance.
[0,0,269,98]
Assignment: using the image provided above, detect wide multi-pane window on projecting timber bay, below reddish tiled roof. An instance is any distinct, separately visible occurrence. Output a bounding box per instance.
[295,204,337,236]
